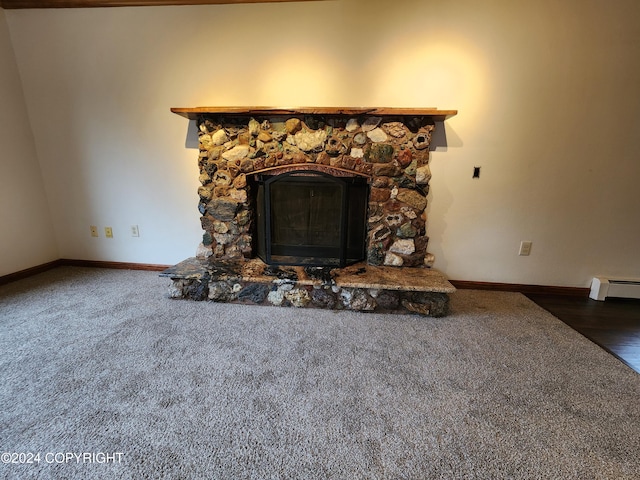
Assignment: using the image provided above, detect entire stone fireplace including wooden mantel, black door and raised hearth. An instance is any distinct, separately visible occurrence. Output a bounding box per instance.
[163,107,456,315]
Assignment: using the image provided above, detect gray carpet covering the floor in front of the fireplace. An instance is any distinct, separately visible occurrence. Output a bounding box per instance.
[0,267,640,479]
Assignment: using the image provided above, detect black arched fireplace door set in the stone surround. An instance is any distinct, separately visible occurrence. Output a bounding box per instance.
[257,172,368,266]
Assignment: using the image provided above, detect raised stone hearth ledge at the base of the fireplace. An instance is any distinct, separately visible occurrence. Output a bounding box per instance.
[160,257,455,317]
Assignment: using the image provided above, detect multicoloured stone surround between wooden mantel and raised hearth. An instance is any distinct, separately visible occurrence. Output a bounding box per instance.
[192,114,434,267]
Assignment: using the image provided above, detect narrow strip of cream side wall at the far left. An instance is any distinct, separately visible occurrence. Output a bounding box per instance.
[0,9,58,276]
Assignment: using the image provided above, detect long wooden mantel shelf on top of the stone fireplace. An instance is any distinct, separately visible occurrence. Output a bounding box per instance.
[171,107,458,122]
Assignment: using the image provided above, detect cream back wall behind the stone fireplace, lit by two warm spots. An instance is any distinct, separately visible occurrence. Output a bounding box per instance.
[6,0,640,287]
